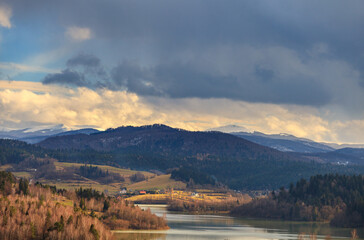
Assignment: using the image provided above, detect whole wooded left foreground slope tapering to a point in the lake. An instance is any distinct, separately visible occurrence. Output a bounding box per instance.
[0,172,168,240]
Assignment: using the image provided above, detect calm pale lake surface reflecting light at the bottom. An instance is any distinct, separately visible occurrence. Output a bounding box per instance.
[115,205,364,240]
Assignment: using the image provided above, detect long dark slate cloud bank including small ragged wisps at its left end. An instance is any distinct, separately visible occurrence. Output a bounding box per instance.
[43,56,330,106]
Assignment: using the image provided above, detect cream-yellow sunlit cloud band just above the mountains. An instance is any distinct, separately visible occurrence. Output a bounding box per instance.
[0,81,364,143]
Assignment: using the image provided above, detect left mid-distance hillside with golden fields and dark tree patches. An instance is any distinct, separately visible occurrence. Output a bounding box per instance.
[0,140,186,195]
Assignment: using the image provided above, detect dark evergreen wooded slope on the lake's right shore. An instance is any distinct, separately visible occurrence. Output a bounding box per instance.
[231,174,364,227]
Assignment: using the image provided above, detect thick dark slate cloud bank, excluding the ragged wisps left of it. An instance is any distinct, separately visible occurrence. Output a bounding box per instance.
[113,63,330,105]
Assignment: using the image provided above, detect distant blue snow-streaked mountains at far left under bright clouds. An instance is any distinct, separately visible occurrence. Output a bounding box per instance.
[0,124,98,144]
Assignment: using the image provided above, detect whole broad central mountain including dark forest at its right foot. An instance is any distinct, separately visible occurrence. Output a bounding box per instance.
[38,124,364,189]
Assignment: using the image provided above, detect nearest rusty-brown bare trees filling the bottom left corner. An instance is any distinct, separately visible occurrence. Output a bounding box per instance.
[0,187,112,239]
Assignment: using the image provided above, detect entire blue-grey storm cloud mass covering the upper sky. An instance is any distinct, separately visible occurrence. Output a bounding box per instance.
[9,0,364,106]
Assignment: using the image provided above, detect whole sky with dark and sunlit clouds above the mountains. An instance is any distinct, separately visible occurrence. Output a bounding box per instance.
[0,0,364,143]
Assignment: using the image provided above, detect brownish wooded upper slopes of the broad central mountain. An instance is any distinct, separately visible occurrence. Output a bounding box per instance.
[39,124,299,161]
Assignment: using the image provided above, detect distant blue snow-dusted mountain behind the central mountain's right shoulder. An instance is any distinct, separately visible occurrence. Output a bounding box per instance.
[231,132,335,153]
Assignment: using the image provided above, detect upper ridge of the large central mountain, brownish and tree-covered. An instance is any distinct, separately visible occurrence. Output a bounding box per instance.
[38,124,291,158]
